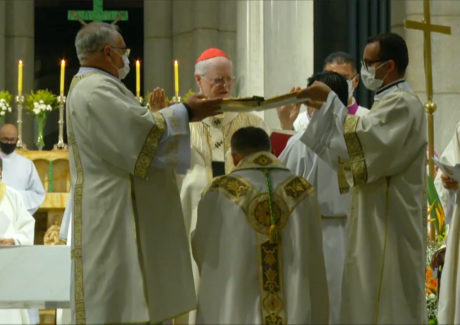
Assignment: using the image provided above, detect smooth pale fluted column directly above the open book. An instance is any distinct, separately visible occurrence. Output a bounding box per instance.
[238,0,314,129]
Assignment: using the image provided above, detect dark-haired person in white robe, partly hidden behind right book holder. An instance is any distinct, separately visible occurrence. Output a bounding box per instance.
[279,71,368,324]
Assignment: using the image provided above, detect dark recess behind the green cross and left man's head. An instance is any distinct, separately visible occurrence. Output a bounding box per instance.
[34,0,144,150]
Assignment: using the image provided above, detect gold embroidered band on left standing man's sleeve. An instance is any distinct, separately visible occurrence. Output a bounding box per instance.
[134,113,166,178]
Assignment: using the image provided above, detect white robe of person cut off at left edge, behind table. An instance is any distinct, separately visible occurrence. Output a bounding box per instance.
[0,182,35,324]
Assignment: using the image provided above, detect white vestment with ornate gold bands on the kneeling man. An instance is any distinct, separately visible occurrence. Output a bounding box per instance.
[192,152,328,324]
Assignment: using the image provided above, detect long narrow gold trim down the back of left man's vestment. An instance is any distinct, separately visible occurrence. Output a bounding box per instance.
[67,73,89,324]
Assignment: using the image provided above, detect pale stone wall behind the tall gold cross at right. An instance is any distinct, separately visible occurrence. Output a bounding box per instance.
[391,0,460,154]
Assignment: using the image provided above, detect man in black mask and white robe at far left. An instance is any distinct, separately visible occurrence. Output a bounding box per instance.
[0,123,46,214]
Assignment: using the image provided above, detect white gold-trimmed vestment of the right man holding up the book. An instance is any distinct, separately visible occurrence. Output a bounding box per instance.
[302,80,427,324]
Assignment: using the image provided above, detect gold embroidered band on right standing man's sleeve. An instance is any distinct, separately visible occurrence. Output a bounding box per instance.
[344,115,367,186]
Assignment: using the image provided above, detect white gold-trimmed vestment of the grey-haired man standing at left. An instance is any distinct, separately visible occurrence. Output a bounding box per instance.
[66,68,196,324]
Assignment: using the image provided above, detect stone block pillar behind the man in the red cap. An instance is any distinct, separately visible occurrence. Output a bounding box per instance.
[144,0,236,96]
